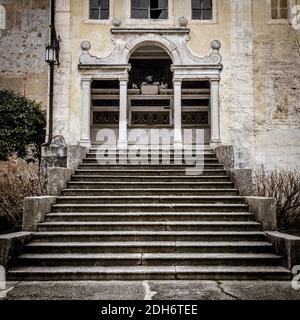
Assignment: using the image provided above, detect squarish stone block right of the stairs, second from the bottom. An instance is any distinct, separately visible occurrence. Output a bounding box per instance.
[245,197,277,231]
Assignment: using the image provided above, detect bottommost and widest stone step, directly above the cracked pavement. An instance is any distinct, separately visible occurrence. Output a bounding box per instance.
[8,266,291,281]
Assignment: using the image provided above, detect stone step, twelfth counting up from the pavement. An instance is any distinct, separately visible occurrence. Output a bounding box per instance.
[75,168,226,177]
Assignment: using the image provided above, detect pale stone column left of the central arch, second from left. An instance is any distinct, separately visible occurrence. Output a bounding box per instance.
[118,79,128,149]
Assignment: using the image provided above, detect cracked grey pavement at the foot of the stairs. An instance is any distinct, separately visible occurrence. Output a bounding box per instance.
[0,281,300,300]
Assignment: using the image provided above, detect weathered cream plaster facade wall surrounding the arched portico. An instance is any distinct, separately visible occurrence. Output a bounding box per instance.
[0,0,300,169]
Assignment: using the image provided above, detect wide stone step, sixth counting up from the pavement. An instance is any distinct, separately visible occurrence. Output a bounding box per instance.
[46,212,255,222]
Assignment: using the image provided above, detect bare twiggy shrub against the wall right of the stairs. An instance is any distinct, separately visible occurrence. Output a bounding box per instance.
[254,167,300,231]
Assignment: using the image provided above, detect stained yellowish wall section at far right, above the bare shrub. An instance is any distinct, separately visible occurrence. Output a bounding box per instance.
[253,1,300,169]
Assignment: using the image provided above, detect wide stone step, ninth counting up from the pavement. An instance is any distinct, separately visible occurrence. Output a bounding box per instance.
[62,188,238,197]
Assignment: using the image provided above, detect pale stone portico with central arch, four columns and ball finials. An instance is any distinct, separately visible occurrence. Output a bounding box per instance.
[78,28,222,147]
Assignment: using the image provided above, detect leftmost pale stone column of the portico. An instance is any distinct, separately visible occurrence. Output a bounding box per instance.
[80,79,91,148]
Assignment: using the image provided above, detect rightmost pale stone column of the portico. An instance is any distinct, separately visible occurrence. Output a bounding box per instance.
[210,80,221,146]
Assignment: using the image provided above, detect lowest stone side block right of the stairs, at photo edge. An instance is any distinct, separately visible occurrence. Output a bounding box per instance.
[267,232,300,270]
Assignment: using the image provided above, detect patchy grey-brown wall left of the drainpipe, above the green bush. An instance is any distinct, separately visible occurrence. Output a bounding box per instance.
[0,0,49,106]
